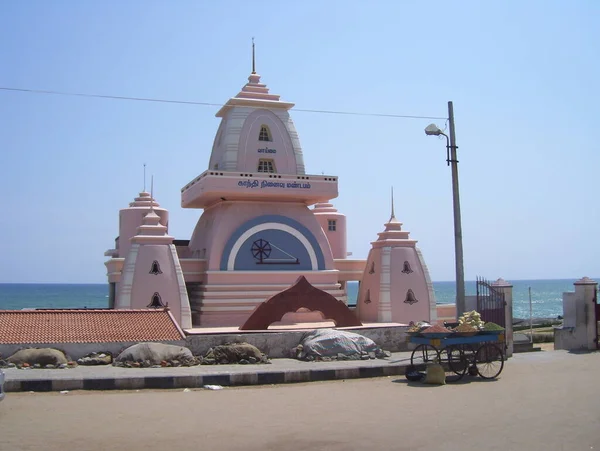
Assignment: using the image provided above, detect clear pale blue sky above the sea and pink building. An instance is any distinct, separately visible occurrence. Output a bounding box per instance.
[0,0,600,283]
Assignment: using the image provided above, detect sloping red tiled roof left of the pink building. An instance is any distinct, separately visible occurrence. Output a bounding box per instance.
[0,309,185,344]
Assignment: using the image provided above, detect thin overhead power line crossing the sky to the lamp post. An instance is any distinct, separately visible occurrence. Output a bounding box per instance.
[0,87,447,120]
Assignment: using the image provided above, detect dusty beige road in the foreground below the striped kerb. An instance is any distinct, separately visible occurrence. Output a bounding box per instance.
[0,351,600,451]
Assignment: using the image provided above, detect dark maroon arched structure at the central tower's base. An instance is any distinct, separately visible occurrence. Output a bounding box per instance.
[240,276,362,330]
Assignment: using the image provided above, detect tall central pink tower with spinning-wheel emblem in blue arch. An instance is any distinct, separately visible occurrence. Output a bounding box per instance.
[181,45,346,326]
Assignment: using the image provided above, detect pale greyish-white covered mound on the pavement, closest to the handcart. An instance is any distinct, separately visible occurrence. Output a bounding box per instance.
[297,329,380,360]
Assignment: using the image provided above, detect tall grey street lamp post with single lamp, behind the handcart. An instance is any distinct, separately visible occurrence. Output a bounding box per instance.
[425,102,466,318]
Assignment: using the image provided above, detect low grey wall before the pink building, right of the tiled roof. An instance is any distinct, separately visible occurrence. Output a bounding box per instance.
[185,326,409,359]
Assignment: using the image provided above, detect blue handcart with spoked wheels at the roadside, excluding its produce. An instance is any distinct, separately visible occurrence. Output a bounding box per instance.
[409,333,505,382]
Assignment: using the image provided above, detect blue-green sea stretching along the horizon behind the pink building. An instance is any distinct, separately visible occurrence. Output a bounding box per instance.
[0,279,599,318]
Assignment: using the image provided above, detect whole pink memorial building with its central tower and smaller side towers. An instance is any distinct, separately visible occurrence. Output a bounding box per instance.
[105,53,435,329]
